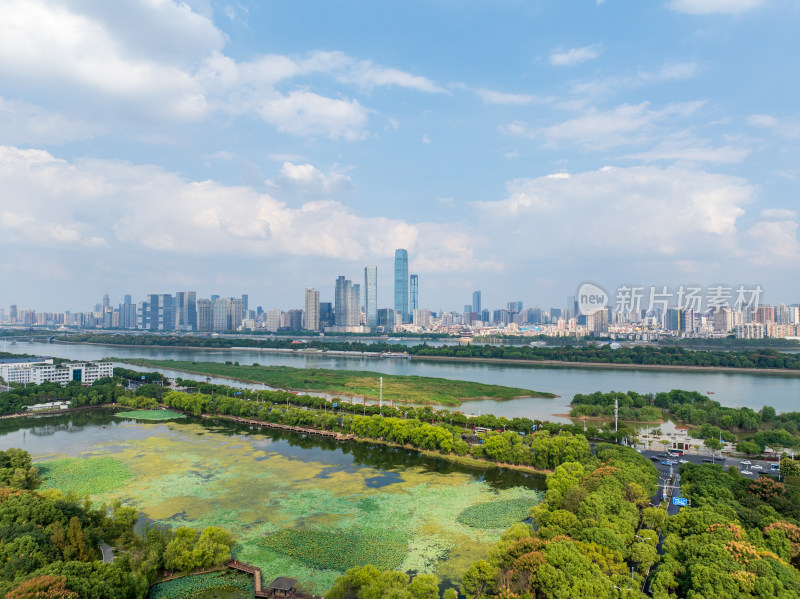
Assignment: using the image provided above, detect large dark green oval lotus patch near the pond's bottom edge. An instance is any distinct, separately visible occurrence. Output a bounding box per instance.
[266,528,408,572]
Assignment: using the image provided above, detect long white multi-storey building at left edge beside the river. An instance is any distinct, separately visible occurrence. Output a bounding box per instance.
[0,358,114,387]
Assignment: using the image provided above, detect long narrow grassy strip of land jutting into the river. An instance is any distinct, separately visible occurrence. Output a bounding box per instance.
[118,358,555,406]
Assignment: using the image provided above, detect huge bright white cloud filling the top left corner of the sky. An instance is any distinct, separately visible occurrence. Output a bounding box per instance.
[0,0,447,143]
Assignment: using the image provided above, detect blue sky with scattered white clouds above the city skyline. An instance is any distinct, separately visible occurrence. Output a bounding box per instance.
[0,0,800,311]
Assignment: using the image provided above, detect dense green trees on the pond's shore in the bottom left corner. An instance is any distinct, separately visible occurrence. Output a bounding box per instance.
[0,448,233,599]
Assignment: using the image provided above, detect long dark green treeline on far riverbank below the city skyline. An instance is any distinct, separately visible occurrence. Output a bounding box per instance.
[62,333,800,370]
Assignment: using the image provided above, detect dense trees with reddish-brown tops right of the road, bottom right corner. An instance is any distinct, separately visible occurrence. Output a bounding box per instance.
[652,464,800,599]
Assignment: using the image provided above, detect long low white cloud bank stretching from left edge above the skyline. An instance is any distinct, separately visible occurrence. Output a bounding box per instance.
[0,146,496,272]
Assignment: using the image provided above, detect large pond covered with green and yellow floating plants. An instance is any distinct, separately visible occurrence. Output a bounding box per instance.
[0,410,544,596]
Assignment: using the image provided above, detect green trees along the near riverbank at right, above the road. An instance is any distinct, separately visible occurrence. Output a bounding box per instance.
[570,389,800,454]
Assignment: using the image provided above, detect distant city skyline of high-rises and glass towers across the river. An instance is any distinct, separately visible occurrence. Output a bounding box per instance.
[0,249,800,341]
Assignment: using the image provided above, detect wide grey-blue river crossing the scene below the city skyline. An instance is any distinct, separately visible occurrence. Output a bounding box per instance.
[0,341,800,420]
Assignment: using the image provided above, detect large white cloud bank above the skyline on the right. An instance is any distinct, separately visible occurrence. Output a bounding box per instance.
[477,166,754,260]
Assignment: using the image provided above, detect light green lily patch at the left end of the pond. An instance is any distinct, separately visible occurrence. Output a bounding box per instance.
[36,456,133,495]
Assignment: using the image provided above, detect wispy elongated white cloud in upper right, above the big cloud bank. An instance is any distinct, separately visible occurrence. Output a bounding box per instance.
[500,102,703,149]
